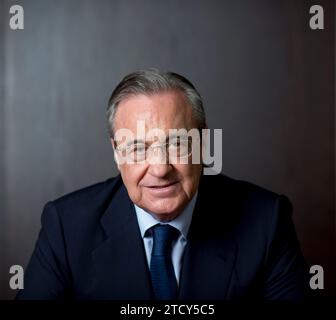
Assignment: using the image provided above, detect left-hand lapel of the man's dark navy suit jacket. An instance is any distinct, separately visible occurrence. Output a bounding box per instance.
[92,184,152,300]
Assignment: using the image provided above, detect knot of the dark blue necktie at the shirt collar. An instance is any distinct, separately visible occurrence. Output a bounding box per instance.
[152,224,179,256]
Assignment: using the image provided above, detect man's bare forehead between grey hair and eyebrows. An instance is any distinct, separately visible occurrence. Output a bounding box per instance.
[115,91,197,132]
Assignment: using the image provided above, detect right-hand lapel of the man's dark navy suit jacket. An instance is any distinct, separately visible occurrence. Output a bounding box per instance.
[179,177,237,300]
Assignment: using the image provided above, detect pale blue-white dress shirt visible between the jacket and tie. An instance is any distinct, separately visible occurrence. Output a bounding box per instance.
[134,192,197,284]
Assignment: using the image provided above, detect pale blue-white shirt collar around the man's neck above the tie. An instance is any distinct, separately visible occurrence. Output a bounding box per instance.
[134,192,197,239]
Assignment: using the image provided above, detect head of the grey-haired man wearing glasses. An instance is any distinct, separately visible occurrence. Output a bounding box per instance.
[107,69,206,221]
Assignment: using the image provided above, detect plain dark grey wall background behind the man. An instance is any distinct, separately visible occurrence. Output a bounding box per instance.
[0,0,336,298]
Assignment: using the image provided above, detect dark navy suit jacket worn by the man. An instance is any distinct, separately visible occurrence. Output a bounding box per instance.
[17,175,306,300]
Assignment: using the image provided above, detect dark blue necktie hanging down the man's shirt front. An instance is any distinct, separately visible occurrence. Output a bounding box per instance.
[149,224,179,300]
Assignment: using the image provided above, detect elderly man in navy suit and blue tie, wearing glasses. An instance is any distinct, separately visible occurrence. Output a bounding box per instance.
[17,70,305,300]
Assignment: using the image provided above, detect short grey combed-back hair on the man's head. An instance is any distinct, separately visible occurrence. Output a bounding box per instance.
[107,69,206,137]
